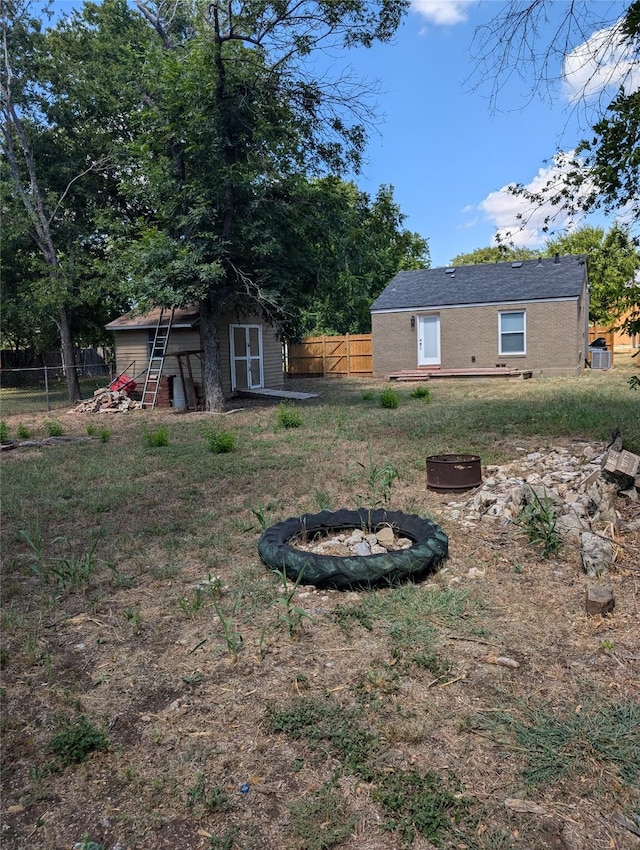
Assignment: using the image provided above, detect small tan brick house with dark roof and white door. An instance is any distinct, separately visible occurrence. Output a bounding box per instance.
[371,255,589,377]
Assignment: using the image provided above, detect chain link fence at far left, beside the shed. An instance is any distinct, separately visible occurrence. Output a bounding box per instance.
[0,363,114,418]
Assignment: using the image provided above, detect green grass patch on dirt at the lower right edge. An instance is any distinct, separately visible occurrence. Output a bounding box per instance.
[474,702,640,786]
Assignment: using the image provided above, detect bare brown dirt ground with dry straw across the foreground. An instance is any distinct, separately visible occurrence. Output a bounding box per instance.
[2,414,640,850]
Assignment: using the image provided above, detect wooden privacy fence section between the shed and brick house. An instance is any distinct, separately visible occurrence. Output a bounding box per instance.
[287,334,373,378]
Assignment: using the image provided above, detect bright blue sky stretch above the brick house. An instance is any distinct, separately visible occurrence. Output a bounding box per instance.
[340,0,637,266]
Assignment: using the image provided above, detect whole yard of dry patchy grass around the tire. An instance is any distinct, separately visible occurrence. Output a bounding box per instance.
[2,362,640,850]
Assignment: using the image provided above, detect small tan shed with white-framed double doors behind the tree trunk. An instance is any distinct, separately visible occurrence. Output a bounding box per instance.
[105,307,284,407]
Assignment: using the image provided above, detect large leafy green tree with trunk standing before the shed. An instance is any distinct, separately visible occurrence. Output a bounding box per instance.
[115,0,408,410]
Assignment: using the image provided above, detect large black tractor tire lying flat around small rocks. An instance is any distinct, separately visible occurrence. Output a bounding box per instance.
[258,508,449,590]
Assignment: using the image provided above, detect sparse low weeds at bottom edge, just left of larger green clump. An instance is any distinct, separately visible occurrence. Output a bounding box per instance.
[287,782,357,850]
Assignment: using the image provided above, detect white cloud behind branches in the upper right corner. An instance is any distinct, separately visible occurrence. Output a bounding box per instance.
[562,21,640,101]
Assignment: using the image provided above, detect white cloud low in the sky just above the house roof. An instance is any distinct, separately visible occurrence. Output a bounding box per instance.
[478,151,589,248]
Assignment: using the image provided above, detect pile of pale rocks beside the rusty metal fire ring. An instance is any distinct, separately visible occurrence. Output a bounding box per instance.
[442,444,640,575]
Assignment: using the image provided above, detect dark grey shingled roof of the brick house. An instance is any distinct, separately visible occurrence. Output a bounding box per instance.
[371,254,586,312]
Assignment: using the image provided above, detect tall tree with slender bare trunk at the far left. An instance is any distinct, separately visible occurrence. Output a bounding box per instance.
[0,0,146,402]
